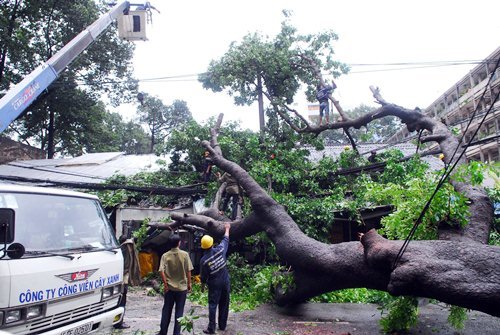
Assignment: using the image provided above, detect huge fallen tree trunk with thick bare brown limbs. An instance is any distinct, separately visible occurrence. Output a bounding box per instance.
[159,94,500,316]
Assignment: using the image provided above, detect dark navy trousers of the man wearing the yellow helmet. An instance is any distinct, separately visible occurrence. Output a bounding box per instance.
[208,282,230,332]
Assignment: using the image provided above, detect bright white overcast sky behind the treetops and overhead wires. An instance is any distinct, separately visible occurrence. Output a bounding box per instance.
[119,0,500,130]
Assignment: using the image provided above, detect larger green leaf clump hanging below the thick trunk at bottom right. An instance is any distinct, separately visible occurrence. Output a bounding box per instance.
[380,297,418,333]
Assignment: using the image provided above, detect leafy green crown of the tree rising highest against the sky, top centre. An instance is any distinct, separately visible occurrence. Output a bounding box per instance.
[199,15,348,127]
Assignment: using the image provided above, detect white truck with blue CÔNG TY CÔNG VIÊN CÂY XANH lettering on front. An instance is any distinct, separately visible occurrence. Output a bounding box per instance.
[0,184,124,335]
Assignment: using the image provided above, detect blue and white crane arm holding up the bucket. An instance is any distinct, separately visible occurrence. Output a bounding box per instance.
[0,1,130,133]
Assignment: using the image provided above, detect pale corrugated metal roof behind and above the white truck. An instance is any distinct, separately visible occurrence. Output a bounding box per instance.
[0,152,170,183]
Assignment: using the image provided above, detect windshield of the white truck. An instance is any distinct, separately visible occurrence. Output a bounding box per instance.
[0,193,118,257]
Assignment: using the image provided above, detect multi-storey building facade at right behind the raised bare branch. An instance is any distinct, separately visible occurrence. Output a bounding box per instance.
[389,47,500,162]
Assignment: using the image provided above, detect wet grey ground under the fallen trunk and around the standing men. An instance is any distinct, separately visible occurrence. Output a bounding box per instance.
[108,288,500,335]
